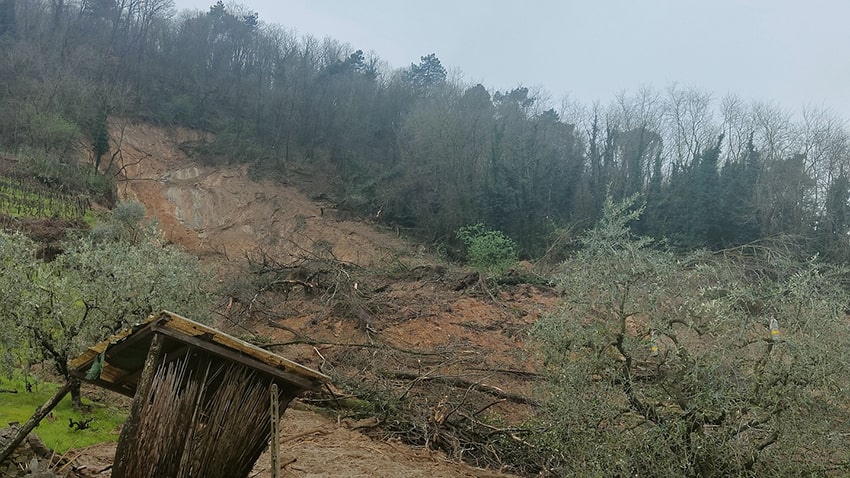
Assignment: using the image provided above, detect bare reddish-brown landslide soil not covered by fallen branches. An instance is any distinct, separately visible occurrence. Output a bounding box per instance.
[64,120,556,477]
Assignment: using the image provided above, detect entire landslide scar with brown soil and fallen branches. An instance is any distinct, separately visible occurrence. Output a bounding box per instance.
[81,120,556,476]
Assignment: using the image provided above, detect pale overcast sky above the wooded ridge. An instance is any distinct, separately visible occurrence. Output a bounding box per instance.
[169,0,850,119]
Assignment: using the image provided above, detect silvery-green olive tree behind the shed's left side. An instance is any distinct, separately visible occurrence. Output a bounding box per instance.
[0,202,211,406]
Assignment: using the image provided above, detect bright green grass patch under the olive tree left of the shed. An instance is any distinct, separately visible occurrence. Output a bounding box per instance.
[0,377,126,453]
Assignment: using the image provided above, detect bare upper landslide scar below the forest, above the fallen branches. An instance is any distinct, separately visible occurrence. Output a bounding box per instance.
[112,116,410,266]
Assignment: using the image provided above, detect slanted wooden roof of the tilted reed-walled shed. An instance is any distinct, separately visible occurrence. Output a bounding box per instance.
[69,311,330,397]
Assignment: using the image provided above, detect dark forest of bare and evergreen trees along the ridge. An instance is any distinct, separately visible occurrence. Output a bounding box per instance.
[0,0,850,261]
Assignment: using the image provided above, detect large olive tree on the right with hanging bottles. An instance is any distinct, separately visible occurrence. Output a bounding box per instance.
[533,198,850,476]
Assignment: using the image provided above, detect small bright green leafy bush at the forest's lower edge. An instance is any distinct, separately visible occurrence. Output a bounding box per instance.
[457,223,517,275]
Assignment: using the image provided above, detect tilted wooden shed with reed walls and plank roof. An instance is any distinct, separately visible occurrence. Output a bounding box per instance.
[70,312,327,478]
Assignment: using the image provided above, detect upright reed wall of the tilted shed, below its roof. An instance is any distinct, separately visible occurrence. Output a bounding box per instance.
[116,350,292,478]
